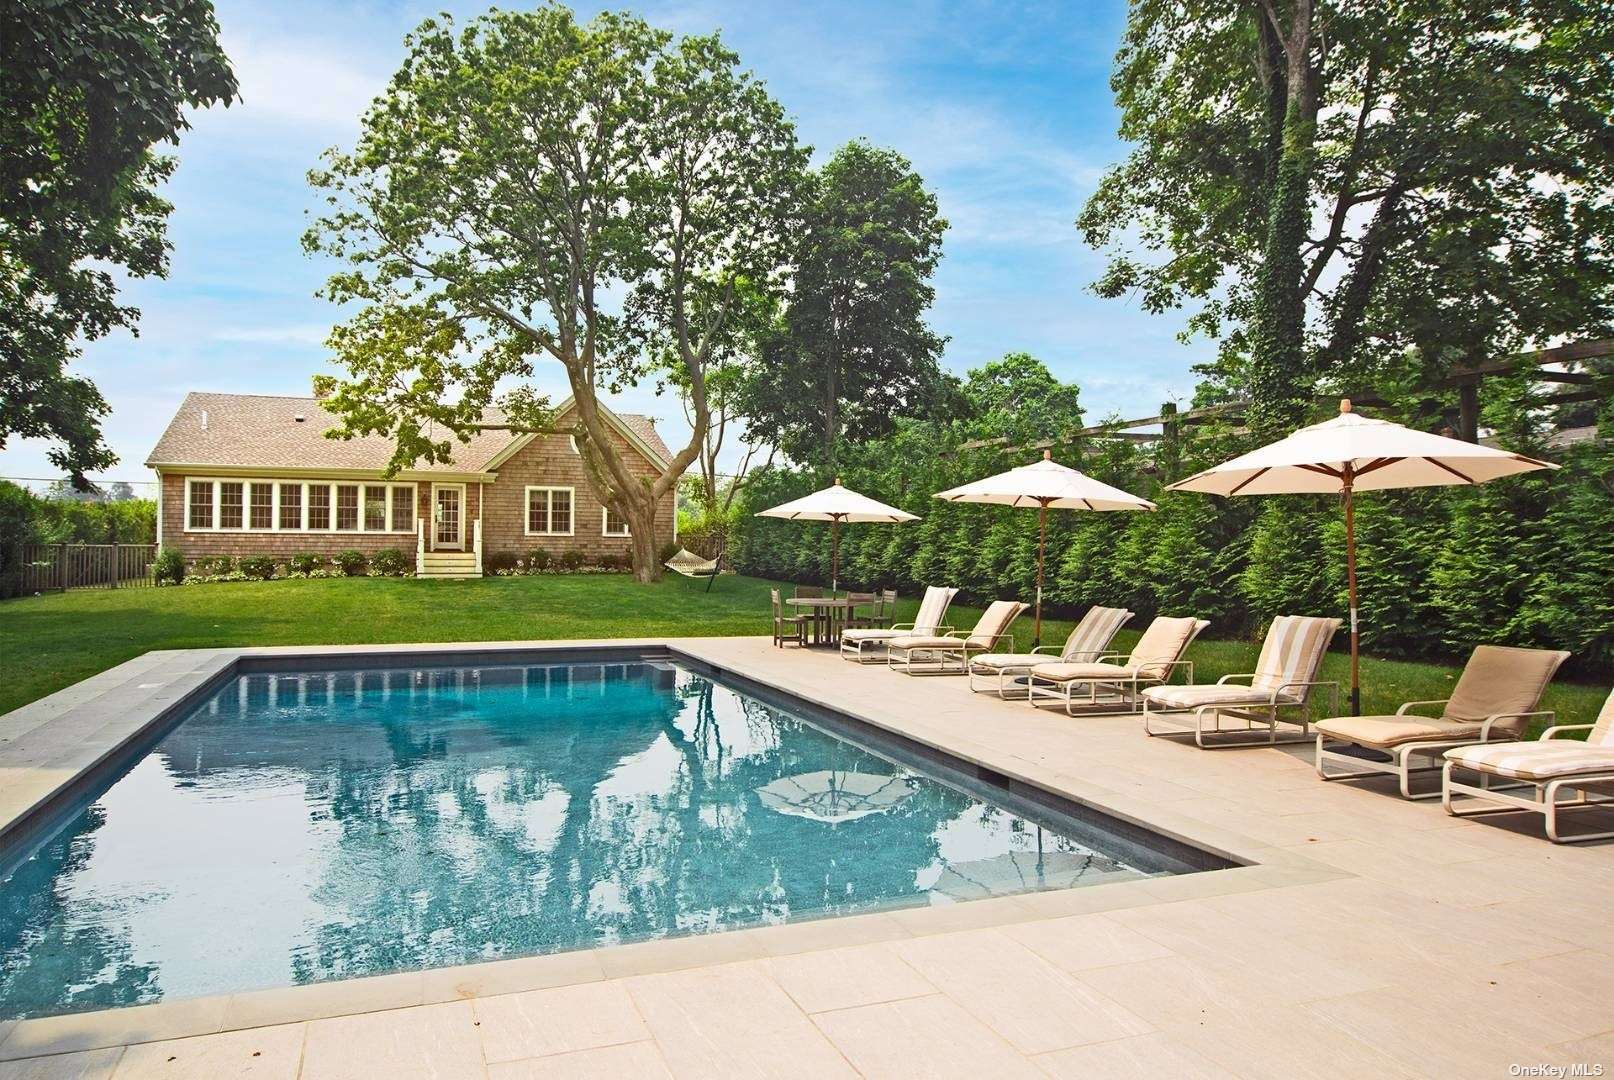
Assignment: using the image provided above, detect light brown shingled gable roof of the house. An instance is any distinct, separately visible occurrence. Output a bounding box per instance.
[145,392,671,473]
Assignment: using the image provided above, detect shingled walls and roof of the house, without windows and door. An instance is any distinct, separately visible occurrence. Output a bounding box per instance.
[147,394,675,562]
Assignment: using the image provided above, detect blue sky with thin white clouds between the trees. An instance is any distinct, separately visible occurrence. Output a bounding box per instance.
[0,0,1209,493]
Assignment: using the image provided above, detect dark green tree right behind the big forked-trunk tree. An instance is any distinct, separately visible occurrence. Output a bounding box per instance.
[746,140,947,470]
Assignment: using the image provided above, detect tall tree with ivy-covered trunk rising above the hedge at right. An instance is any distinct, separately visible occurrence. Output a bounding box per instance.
[1080,0,1614,431]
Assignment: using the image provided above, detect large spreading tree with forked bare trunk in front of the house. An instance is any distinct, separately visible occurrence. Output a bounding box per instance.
[305,5,805,581]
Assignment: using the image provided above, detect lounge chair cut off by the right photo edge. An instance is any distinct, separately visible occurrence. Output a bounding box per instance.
[1440,694,1614,844]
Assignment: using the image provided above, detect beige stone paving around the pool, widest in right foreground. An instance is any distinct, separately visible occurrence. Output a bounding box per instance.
[0,639,1614,1080]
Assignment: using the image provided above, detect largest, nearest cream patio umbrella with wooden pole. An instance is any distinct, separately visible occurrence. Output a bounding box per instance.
[1169,399,1558,717]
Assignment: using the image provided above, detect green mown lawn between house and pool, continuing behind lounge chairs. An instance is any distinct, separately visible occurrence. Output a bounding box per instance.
[0,575,1608,723]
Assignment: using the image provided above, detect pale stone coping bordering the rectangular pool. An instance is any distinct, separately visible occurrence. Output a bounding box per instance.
[0,638,1354,1061]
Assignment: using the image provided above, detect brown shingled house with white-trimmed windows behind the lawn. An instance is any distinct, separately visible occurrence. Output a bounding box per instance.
[145,394,676,576]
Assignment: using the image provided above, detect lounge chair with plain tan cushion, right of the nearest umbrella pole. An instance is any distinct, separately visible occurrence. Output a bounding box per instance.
[1312,646,1569,799]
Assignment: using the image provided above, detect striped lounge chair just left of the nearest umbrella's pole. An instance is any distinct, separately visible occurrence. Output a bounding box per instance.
[1143,615,1340,749]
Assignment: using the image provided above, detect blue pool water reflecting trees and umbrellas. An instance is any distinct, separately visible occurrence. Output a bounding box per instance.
[0,662,1188,1019]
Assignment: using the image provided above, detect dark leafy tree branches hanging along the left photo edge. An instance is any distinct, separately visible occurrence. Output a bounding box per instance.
[0,0,236,488]
